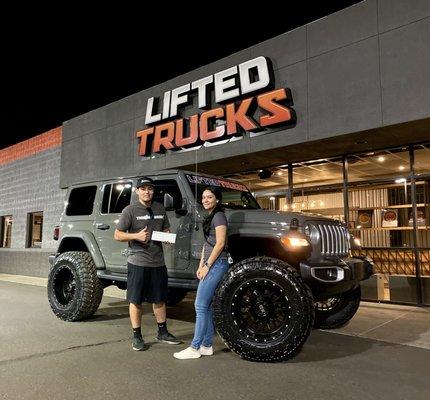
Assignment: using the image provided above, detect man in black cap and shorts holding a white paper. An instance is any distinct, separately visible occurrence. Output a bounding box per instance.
[114,176,181,351]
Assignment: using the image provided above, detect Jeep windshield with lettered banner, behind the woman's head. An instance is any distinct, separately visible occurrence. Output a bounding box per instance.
[186,174,261,210]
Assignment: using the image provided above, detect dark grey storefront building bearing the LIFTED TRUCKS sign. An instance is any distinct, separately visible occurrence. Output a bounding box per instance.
[0,0,430,304]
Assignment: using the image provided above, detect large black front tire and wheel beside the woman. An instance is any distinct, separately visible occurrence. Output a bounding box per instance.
[214,257,314,362]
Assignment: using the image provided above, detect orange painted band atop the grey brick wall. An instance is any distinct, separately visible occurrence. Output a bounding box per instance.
[0,126,63,165]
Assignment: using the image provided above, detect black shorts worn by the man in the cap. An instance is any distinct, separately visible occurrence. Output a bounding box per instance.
[127,263,167,304]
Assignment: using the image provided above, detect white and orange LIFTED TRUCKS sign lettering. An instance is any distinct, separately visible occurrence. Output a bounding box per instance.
[136,56,296,156]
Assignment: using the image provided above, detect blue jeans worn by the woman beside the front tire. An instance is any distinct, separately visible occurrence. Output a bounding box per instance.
[191,259,229,349]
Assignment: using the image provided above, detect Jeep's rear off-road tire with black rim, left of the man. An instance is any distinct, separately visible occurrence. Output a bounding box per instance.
[47,251,103,321]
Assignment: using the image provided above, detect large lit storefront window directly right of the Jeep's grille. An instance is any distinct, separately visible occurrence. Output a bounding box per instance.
[348,148,422,303]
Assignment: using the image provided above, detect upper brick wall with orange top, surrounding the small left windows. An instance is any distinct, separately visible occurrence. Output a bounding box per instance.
[0,127,65,251]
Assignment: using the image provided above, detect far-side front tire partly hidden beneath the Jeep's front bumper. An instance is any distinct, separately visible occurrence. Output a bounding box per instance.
[314,285,361,329]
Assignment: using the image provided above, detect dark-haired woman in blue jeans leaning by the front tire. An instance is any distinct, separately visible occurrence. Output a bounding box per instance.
[173,186,229,360]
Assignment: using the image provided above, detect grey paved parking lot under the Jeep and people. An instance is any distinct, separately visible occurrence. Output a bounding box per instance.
[0,277,430,400]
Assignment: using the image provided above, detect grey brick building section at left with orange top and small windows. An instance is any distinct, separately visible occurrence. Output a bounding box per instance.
[0,127,65,276]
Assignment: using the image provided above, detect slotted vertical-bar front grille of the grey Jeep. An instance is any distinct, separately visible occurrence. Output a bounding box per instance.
[316,224,349,256]
